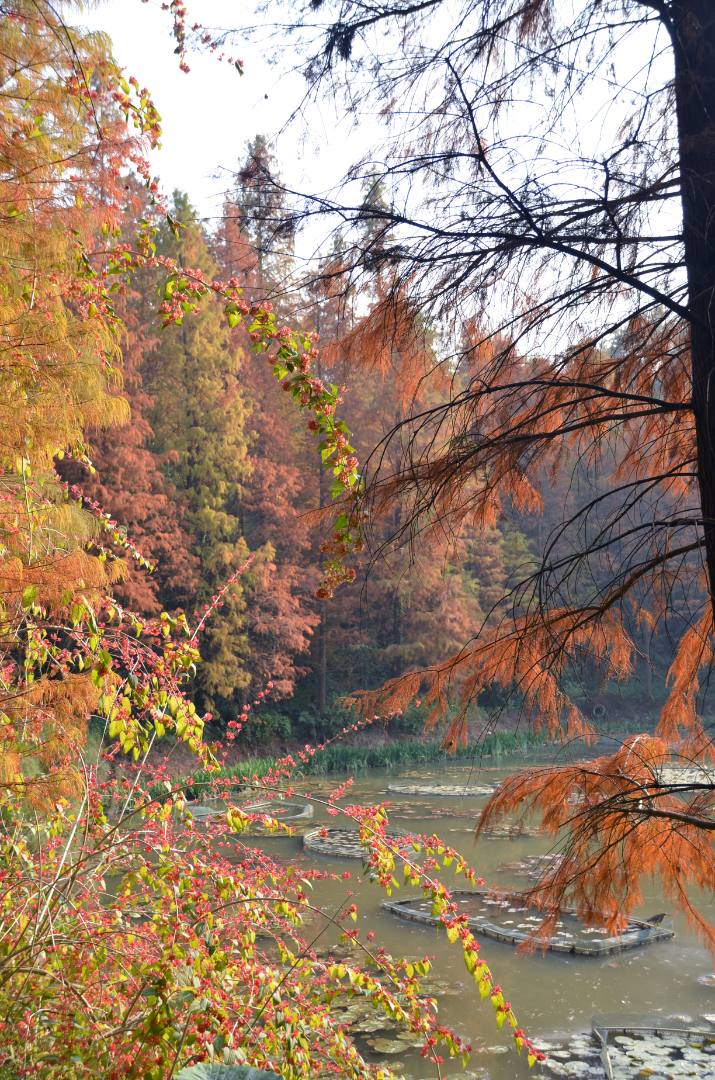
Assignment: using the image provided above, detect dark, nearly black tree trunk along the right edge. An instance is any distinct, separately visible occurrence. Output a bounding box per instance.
[671,0,715,609]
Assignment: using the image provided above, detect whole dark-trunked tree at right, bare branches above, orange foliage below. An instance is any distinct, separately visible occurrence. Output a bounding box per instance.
[245,0,715,937]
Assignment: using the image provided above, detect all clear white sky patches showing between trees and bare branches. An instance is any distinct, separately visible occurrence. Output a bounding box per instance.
[81,0,677,351]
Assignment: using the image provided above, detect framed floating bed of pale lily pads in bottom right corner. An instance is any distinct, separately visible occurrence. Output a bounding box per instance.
[592,1015,715,1080]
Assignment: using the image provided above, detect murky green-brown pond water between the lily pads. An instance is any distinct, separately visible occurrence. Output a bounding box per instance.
[240,757,715,1080]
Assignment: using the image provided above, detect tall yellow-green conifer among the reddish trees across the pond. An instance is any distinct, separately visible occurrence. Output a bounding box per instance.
[143,192,251,715]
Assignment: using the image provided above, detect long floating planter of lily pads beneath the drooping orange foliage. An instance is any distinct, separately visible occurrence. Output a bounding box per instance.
[382,889,674,956]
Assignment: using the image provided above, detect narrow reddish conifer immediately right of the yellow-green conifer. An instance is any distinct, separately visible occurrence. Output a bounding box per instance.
[215,152,318,698]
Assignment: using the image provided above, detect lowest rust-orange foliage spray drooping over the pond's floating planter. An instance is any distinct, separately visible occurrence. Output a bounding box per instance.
[477,734,715,949]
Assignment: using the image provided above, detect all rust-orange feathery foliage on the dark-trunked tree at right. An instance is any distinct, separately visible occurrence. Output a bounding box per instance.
[343,300,715,933]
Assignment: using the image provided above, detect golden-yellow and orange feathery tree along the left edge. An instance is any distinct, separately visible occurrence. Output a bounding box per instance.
[0,0,158,807]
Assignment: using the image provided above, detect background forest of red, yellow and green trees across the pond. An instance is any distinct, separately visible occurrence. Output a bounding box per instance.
[68,136,688,746]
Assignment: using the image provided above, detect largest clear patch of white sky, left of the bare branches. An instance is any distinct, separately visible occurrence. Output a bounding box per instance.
[79,0,354,221]
